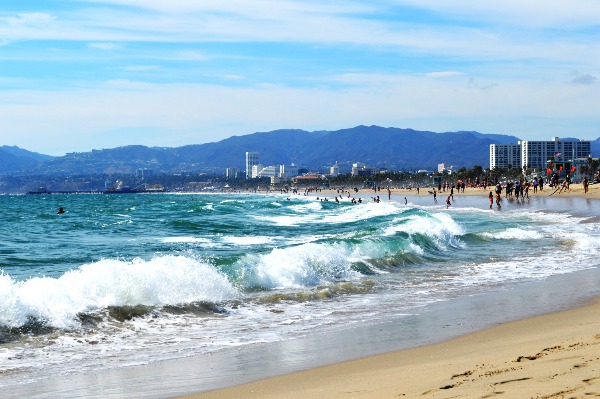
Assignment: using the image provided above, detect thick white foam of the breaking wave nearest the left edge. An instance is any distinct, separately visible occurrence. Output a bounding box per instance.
[0,256,237,329]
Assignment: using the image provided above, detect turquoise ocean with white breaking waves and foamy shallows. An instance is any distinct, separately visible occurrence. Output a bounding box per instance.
[0,191,600,397]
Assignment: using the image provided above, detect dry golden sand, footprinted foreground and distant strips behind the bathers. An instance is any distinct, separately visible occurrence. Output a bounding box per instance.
[179,184,600,399]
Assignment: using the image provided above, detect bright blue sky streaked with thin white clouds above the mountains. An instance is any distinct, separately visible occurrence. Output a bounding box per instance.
[0,0,600,155]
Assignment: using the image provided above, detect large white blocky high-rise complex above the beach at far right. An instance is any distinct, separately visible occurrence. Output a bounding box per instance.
[490,137,591,176]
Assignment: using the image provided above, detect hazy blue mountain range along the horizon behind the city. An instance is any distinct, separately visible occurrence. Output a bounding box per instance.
[0,126,600,175]
